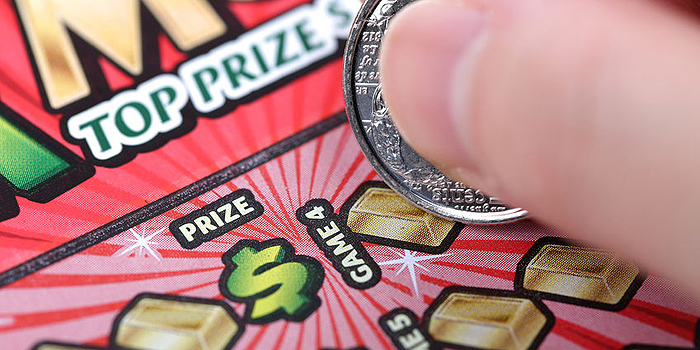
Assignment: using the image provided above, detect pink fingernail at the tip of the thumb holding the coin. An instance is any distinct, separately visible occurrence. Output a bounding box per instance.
[380,0,486,180]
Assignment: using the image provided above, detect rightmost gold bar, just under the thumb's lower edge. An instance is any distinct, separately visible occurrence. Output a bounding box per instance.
[523,244,639,304]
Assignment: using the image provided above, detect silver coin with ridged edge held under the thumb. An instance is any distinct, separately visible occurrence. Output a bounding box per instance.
[343,0,527,223]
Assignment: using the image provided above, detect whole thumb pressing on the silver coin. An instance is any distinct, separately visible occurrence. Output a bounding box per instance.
[380,0,700,296]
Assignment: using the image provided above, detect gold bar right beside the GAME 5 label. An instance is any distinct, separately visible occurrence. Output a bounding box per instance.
[428,293,547,350]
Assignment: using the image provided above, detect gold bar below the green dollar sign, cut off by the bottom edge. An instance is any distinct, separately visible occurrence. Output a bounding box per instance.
[115,298,238,350]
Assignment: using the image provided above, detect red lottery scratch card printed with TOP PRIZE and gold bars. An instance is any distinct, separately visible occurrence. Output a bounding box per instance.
[0,0,699,350]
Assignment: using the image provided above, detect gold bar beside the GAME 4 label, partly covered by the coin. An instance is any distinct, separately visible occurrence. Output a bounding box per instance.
[348,187,455,247]
